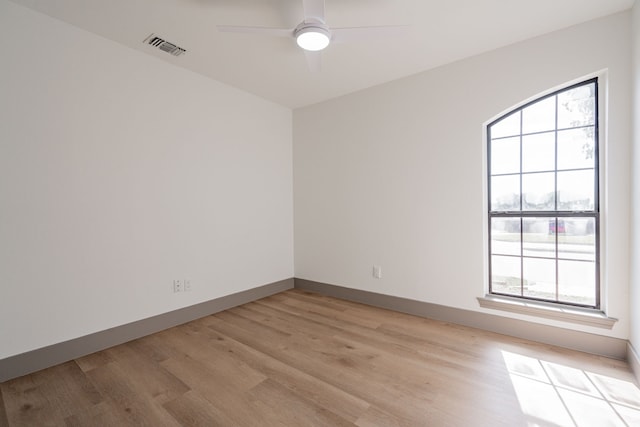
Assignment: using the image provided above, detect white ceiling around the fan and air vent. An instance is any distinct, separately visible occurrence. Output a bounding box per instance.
[13,0,634,108]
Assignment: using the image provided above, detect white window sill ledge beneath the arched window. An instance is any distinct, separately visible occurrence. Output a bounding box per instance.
[478,295,618,329]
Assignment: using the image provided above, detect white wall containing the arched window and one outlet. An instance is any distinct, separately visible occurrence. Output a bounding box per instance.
[293,12,630,339]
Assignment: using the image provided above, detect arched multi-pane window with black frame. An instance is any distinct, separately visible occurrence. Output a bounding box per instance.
[487,79,600,308]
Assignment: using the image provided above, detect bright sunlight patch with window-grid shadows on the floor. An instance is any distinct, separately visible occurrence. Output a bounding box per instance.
[502,351,640,427]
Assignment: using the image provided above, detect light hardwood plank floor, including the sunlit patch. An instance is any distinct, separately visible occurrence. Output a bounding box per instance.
[0,290,640,427]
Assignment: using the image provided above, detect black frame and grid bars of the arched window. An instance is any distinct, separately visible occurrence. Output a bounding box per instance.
[486,77,601,309]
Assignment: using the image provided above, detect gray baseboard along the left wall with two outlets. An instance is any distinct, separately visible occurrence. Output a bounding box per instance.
[0,278,294,382]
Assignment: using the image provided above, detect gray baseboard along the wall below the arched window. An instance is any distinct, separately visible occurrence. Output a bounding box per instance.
[295,278,628,360]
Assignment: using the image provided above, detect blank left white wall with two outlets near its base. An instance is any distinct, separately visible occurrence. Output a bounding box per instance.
[0,0,293,359]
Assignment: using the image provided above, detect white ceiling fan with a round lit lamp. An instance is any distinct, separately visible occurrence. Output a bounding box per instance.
[218,0,406,71]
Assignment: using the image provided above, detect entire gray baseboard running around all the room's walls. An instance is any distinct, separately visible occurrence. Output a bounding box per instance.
[0,278,640,383]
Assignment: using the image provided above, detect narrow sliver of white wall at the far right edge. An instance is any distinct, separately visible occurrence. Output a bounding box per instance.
[629,2,640,352]
